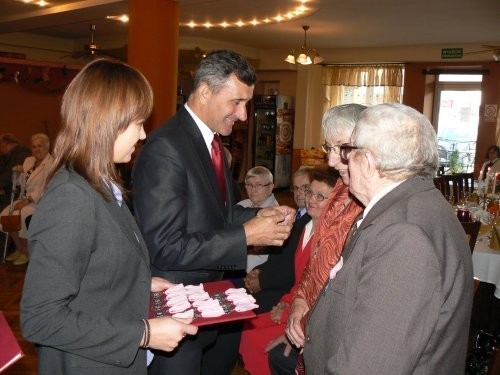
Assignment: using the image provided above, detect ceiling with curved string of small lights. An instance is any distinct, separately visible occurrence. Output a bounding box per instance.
[0,0,500,59]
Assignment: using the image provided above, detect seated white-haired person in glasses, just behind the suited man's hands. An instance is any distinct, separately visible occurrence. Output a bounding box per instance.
[238,166,279,272]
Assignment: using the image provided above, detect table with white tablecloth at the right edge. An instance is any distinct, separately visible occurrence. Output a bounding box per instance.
[472,234,500,298]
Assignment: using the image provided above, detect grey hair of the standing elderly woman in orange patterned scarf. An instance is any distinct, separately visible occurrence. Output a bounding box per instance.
[321,103,366,138]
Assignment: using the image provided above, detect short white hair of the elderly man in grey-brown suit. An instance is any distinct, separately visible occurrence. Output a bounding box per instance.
[351,103,439,181]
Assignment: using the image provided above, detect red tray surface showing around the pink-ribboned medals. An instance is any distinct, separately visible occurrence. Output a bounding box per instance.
[149,280,255,327]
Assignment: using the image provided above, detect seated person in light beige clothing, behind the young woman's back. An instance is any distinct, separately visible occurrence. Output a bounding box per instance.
[0,133,54,265]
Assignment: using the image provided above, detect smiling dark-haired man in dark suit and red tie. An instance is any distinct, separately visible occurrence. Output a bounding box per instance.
[132,51,295,375]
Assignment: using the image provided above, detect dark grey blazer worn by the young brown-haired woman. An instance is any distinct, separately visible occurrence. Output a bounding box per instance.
[21,169,151,375]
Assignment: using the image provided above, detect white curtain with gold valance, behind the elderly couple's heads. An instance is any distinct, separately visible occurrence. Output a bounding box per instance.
[322,64,404,112]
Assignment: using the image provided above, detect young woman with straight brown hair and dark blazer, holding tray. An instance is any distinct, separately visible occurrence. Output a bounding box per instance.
[21,59,197,375]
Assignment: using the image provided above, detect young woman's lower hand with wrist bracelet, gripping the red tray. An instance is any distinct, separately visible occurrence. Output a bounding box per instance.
[148,316,198,352]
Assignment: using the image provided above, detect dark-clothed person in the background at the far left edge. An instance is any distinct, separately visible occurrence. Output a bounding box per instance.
[0,133,31,210]
